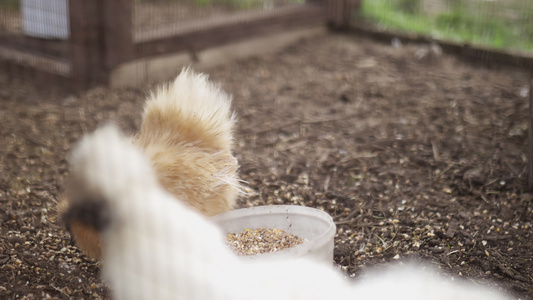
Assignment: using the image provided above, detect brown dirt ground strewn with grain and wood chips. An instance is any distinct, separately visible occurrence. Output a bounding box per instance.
[0,35,533,299]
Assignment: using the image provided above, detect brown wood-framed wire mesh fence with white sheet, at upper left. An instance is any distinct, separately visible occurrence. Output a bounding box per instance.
[0,0,325,86]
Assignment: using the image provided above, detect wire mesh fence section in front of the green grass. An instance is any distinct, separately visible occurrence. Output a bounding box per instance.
[359,0,533,53]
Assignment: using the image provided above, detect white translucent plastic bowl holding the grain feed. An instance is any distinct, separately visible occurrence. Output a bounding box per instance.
[213,205,336,263]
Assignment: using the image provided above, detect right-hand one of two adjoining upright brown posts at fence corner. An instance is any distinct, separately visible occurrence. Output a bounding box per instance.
[102,0,134,69]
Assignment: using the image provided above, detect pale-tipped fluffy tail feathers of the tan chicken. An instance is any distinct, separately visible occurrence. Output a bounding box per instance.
[138,68,235,151]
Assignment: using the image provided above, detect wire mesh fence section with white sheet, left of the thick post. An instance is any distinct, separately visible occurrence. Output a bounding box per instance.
[0,0,70,84]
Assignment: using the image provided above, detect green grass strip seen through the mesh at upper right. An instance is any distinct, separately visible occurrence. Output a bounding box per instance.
[362,0,533,52]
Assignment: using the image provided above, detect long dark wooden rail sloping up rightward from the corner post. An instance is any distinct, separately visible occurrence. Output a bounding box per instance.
[135,4,327,58]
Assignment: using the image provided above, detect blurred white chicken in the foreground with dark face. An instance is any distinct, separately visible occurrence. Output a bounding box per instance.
[63,127,507,300]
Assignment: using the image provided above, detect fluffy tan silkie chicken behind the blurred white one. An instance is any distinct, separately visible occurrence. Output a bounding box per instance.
[57,69,241,258]
